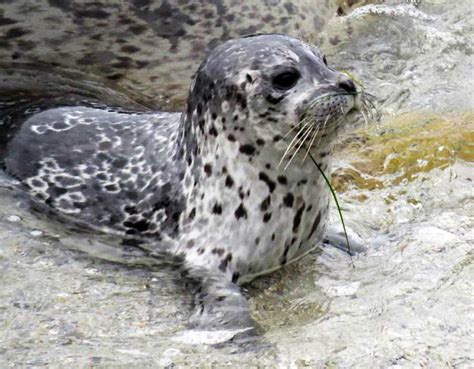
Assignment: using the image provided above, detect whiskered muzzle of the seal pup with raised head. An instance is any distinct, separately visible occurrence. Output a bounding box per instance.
[279,91,378,170]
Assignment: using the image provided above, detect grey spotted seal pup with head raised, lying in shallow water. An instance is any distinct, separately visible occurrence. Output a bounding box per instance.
[0,34,361,332]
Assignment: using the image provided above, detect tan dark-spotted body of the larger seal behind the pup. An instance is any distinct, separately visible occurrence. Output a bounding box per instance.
[0,0,337,107]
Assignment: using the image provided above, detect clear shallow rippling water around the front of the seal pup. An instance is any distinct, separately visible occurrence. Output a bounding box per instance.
[0,0,474,368]
